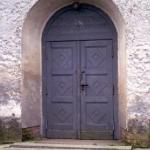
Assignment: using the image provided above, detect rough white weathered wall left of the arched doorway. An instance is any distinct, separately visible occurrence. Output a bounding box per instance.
[0,0,36,117]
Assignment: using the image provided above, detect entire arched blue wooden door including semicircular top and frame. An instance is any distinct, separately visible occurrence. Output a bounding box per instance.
[42,3,117,139]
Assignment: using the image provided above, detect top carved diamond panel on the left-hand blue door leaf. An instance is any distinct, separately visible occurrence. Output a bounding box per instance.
[52,48,73,70]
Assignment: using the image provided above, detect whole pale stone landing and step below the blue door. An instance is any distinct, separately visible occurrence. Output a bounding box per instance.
[0,140,132,150]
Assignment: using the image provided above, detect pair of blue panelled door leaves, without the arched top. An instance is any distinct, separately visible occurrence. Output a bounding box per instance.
[46,40,114,139]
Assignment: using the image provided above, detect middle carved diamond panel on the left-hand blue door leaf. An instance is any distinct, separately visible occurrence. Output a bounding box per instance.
[53,76,73,96]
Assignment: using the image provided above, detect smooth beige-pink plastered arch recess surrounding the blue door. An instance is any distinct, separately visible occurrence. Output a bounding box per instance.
[22,0,126,138]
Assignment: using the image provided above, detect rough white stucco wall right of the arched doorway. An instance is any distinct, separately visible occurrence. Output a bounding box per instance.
[115,0,150,130]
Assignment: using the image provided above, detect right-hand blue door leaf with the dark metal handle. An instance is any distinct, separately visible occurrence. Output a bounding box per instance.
[81,40,113,139]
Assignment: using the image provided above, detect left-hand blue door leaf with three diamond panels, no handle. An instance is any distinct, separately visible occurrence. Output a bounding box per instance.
[47,42,77,138]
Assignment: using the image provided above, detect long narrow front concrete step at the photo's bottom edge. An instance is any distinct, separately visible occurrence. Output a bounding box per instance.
[10,142,132,150]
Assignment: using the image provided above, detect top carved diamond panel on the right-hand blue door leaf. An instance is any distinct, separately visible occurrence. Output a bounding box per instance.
[86,47,106,68]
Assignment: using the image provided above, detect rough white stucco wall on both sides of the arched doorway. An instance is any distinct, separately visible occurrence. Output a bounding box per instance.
[0,0,150,141]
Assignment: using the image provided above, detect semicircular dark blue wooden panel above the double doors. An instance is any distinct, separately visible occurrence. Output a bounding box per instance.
[45,4,116,41]
